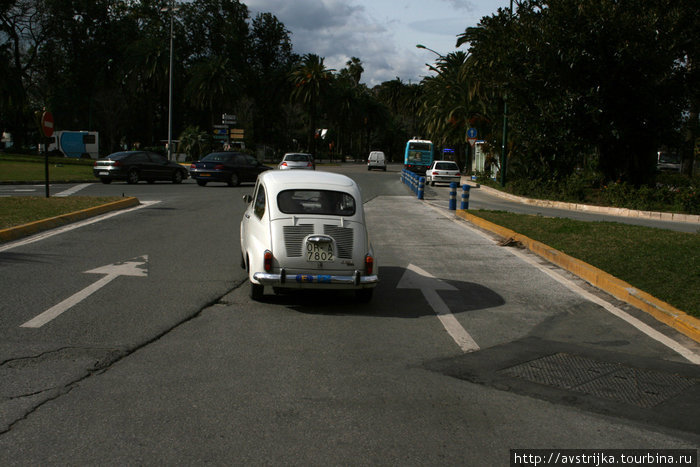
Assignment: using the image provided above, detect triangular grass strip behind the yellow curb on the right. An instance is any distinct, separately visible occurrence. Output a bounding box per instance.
[469,210,700,318]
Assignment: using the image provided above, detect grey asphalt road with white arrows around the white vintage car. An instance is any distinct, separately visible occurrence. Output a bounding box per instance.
[0,166,700,465]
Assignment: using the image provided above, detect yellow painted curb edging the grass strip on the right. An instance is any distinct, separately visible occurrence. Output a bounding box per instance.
[457,210,700,342]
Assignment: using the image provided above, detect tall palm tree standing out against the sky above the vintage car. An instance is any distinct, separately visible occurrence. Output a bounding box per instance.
[290,54,335,154]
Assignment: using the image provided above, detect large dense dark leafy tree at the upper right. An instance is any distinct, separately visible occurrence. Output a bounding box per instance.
[457,0,689,184]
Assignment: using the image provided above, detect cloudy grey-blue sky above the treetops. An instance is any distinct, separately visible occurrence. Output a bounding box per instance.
[242,0,510,87]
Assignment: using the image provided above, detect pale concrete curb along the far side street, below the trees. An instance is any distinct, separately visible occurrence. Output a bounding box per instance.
[462,176,700,224]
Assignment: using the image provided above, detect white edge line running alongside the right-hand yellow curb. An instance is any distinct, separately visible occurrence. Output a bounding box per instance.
[428,205,700,365]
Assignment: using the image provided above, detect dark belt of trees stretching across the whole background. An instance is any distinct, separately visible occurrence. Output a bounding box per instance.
[0,0,700,205]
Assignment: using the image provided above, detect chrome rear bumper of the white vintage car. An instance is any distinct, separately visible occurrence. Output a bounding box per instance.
[253,269,379,289]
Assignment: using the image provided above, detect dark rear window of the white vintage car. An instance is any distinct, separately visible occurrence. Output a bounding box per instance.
[277,189,355,216]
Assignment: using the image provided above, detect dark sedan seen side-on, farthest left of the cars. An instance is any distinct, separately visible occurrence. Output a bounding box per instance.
[92,151,187,183]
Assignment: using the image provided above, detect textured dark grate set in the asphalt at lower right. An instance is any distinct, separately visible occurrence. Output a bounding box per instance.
[499,353,698,408]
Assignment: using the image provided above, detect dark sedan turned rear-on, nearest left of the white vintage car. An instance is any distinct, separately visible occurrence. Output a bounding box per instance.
[190,151,270,186]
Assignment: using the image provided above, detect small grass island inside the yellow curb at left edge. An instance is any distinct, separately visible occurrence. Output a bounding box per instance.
[0,196,122,230]
